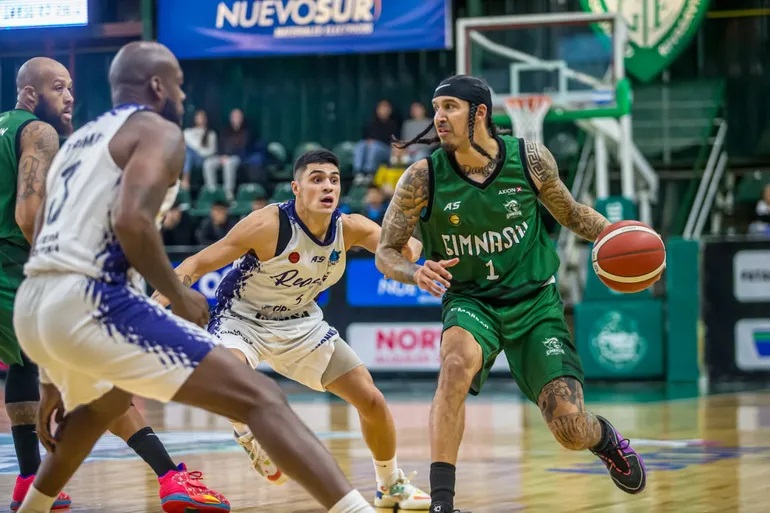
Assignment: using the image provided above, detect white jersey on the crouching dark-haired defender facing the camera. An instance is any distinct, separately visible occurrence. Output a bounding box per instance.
[214,201,345,320]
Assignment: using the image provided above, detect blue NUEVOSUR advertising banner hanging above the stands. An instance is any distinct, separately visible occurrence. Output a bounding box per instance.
[158,0,452,59]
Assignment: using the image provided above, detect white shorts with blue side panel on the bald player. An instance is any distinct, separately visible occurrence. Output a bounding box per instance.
[14,274,216,411]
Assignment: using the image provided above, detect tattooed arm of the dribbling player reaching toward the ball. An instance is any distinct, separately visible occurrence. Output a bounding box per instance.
[524,141,610,241]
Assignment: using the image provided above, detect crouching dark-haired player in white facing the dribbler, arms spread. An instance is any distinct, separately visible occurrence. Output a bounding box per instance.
[153,150,430,510]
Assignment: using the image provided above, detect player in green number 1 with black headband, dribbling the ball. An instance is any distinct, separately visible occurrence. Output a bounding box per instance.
[376,75,646,513]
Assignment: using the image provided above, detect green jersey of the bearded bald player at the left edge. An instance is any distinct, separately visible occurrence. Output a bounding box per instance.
[0,109,37,247]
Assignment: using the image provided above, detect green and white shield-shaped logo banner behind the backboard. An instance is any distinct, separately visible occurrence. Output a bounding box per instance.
[580,0,709,82]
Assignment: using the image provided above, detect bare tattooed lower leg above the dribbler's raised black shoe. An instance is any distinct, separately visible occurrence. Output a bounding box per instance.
[537,377,602,451]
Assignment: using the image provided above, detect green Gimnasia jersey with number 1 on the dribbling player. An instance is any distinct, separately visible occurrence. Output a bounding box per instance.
[420,136,559,302]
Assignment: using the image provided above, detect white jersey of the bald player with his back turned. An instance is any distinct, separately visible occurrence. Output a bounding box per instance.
[24,101,179,287]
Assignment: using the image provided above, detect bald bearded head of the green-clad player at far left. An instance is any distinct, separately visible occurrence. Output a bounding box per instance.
[16,57,75,135]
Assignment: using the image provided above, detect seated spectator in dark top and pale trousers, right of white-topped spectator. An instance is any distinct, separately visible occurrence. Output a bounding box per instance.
[203,109,251,201]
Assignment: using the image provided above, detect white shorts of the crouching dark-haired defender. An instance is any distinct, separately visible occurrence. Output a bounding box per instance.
[209,304,361,392]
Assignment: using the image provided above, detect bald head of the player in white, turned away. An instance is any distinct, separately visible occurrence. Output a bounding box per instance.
[109,41,184,123]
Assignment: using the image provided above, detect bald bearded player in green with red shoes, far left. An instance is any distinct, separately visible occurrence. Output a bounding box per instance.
[0,57,229,512]
